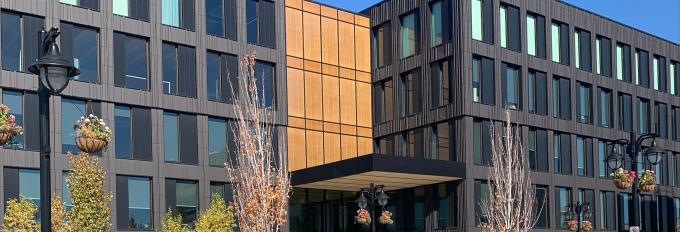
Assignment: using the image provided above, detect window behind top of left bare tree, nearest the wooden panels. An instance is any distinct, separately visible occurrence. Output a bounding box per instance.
[255,61,276,109]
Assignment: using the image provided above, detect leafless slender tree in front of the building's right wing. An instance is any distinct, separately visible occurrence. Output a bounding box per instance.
[479,112,544,232]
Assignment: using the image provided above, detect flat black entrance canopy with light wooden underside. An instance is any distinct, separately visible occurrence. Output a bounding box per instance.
[291,154,465,191]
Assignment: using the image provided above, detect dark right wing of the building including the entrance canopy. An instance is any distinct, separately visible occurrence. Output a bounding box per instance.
[291,0,680,231]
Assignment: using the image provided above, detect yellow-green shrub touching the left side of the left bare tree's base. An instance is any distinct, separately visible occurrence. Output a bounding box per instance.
[196,194,236,232]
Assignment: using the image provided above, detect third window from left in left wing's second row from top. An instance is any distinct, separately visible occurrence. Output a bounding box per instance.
[125,36,149,90]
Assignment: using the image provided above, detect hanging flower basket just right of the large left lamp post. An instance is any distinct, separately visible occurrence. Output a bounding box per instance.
[73,114,111,153]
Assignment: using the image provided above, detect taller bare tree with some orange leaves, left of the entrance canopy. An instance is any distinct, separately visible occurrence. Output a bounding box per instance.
[225,53,291,232]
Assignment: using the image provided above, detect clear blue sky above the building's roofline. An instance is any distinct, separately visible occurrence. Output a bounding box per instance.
[316,0,680,44]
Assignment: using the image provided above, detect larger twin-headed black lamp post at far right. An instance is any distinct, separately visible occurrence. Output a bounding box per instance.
[606,132,665,229]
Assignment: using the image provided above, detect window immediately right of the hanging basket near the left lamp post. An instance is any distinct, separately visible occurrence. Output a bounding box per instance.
[114,105,132,159]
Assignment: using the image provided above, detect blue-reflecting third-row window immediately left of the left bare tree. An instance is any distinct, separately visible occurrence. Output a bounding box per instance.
[208,118,227,167]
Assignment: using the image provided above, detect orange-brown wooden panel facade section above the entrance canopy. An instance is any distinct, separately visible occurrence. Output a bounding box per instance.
[285,0,373,171]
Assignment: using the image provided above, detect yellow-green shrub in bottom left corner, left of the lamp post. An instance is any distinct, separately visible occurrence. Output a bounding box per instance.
[2,197,40,232]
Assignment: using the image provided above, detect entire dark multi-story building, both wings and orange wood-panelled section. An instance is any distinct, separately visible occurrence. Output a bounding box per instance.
[0,0,680,231]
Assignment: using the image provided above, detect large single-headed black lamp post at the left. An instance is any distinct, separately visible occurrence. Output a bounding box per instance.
[28,27,80,231]
